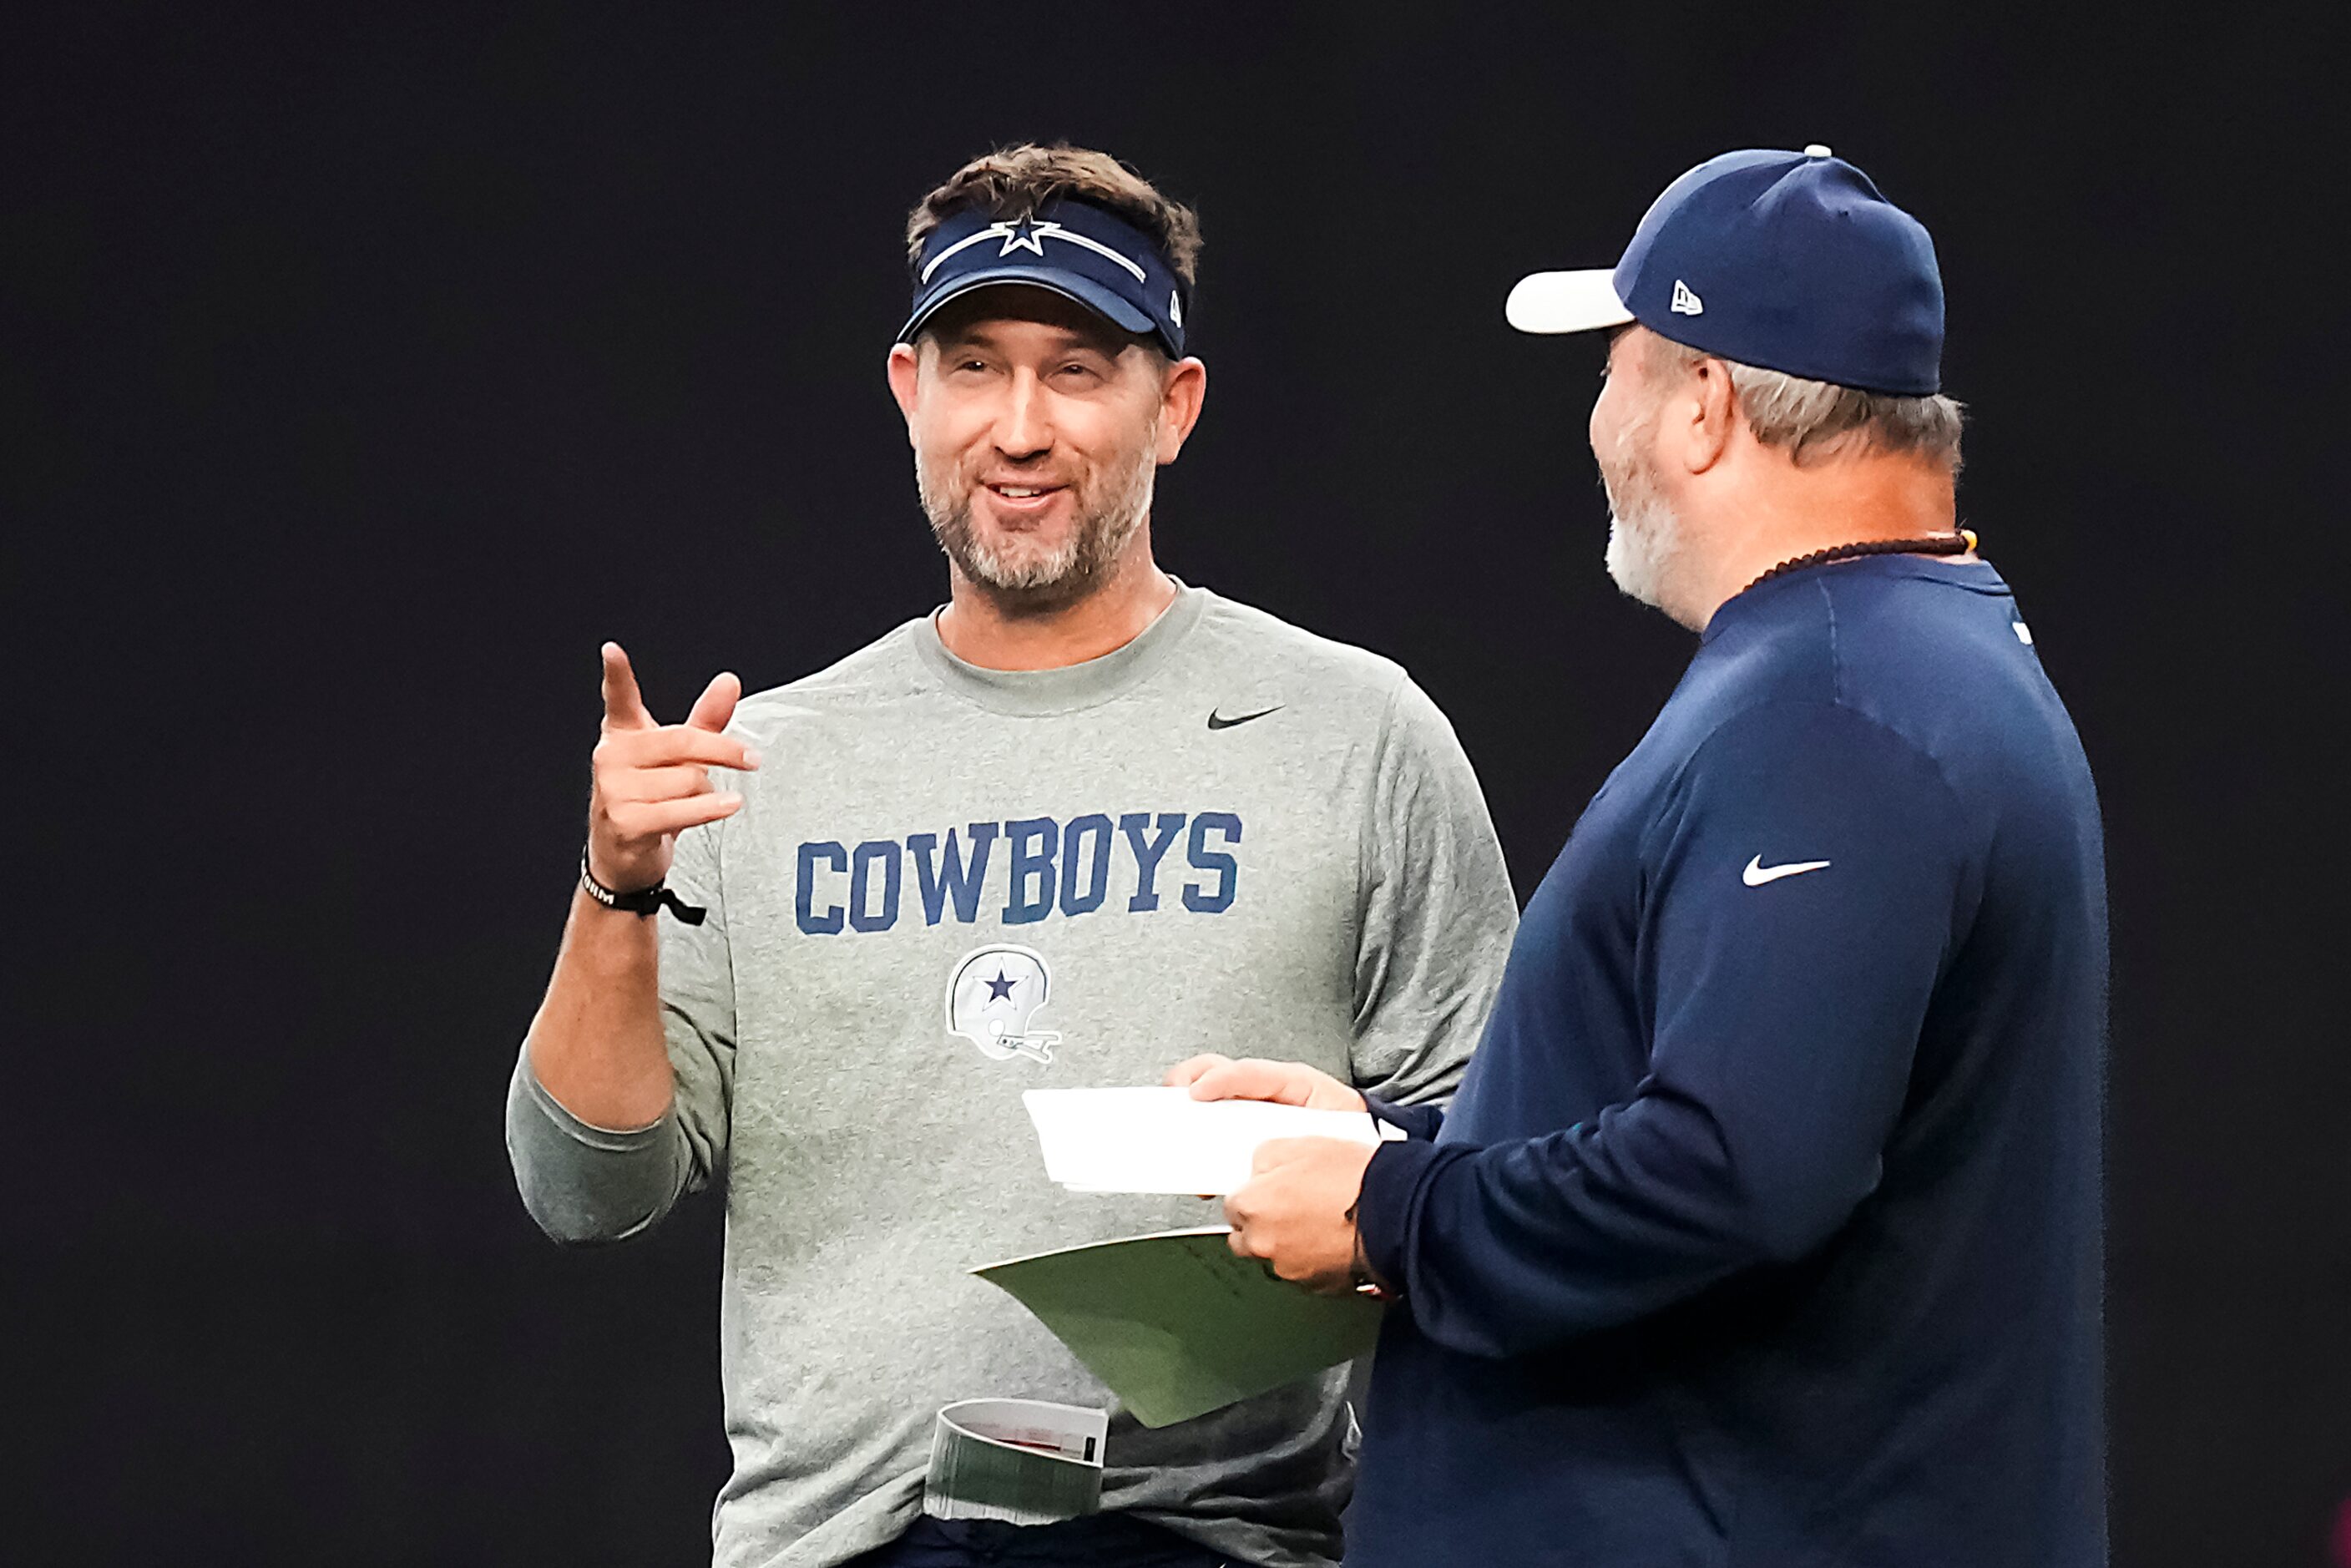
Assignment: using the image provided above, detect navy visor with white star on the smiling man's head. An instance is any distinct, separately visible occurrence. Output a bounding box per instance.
[898,198,1192,360]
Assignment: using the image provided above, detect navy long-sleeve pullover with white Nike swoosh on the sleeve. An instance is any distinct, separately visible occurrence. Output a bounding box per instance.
[1347,557,2106,1568]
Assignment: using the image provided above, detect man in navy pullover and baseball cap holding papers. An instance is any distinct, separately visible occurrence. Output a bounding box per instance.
[1176,146,2106,1568]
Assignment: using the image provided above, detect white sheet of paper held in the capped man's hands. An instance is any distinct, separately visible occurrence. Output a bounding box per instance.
[1020,1089,1403,1194]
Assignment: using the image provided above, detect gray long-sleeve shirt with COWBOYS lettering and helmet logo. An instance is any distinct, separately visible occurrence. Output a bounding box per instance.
[508,588,1516,1568]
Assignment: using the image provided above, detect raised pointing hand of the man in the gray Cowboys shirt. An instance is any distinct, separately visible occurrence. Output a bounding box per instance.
[588,642,760,893]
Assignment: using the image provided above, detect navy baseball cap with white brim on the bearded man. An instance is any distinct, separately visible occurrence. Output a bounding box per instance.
[1502,146,1942,397]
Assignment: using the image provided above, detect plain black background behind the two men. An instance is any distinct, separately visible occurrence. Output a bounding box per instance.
[0,3,2351,1568]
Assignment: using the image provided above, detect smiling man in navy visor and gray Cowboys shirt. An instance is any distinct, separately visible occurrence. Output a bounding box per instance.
[508,146,1516,1568]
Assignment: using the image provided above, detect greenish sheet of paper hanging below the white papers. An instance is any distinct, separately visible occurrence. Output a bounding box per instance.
[971,1222,1380,1427]
